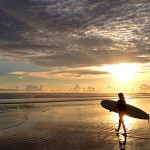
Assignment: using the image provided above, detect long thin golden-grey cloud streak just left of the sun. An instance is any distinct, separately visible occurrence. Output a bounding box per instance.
[10,68,109,79]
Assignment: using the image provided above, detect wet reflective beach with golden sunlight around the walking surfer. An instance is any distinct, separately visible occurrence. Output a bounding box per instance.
[0,94,150,150]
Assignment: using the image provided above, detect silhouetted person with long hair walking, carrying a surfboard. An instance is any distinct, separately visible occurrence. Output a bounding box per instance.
[110,93,126,134]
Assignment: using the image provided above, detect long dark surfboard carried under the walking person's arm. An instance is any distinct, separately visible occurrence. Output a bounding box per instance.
[101,100,149,120]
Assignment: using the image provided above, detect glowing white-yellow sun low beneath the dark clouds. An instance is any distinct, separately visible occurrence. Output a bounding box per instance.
[103,63,138,82]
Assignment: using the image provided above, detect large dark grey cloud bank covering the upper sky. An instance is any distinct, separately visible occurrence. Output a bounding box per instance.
[0,0,150,67]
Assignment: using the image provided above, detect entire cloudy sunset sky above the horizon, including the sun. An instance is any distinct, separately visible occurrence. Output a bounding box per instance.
[0,0,150,92]
